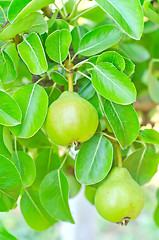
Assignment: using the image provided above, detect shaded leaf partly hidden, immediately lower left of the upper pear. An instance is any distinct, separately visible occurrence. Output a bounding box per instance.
[17,129,51,148]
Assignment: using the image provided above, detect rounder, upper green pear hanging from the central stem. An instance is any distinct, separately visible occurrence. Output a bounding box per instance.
[45,91,99,146]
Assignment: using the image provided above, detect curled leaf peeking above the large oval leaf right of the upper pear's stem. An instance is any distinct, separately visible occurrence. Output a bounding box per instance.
[97,51,125,71]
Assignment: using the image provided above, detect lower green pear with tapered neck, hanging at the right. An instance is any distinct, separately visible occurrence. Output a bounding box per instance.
[95,167,145,225]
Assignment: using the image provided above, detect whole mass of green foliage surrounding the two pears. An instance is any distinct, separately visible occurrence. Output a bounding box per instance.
[0,0,159,239]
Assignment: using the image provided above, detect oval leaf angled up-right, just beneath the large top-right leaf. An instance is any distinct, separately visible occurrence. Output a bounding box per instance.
[78,25,122,57]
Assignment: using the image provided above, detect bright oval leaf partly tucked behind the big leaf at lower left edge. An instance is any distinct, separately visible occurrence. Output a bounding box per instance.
[13,151,36,187]
